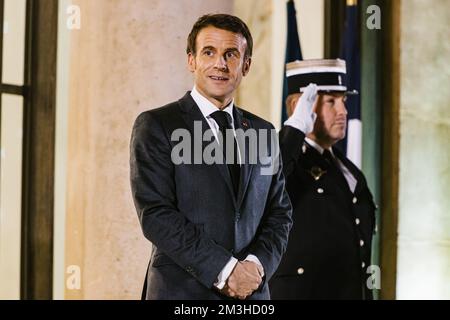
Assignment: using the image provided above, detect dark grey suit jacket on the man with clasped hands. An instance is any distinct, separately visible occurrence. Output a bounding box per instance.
[130,92,292,299]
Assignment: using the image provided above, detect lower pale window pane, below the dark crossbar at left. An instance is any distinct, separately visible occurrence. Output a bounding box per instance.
[0,94,23,300]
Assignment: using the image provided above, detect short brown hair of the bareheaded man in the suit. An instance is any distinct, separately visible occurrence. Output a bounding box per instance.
[186,14,253,58]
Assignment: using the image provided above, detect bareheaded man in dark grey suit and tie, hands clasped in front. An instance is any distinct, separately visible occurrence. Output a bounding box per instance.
[130,14,292,299]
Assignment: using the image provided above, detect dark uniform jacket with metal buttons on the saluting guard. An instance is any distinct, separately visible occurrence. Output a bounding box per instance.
[270,126,375,299]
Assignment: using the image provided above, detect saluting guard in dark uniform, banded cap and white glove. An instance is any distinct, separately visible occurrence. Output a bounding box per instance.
[270,60,375,299]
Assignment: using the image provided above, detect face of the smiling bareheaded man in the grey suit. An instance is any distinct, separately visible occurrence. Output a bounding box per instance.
[188,26,251,106]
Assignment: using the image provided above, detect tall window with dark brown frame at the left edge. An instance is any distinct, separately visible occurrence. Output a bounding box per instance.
[0,0,58,299]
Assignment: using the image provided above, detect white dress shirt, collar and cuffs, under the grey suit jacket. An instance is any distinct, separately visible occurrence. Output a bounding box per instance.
[191,86,262,289]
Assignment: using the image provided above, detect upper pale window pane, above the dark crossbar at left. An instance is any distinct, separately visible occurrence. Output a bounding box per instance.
[3,0,26,86]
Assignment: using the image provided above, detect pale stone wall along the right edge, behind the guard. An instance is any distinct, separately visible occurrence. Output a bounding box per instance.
[397,0,450,299]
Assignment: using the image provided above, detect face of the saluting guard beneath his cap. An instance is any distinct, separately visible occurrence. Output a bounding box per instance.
[313,93,347,145]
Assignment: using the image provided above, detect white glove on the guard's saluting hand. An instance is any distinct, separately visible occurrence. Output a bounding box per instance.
[284,83,317,135]
